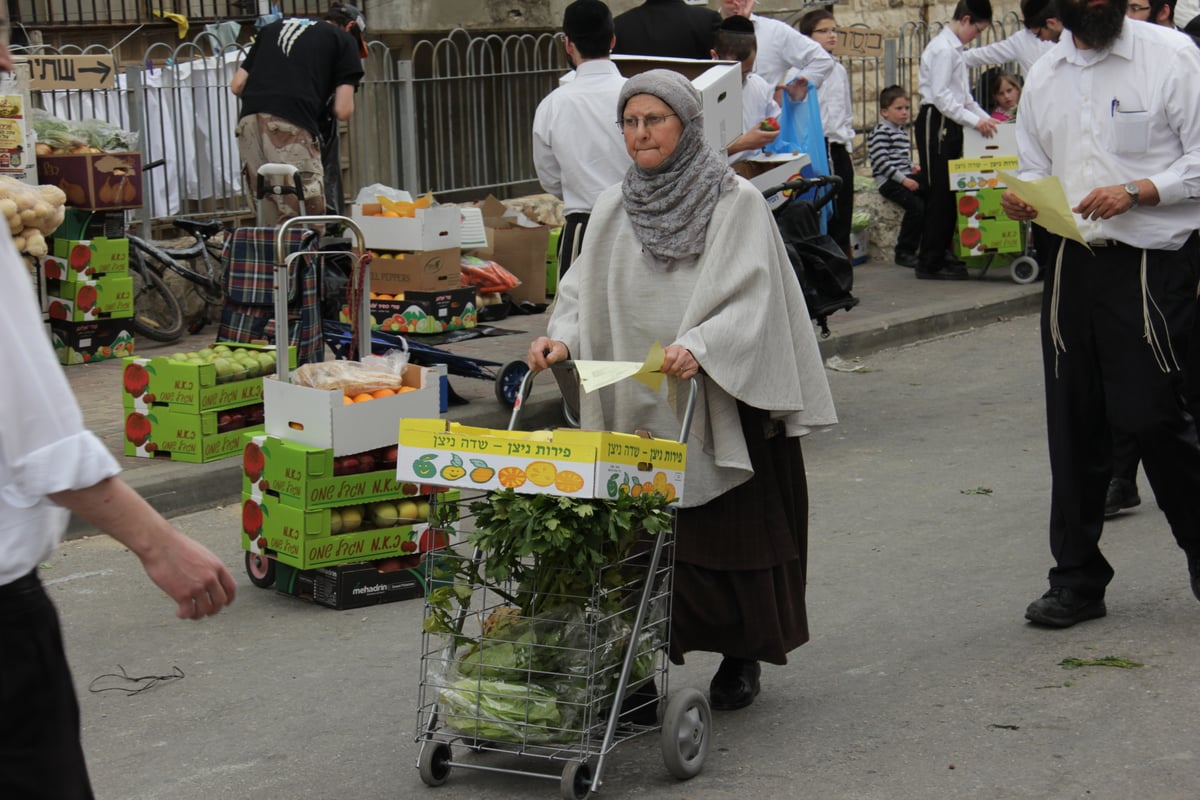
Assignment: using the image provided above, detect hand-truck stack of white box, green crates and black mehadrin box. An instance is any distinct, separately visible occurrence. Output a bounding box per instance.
[241,365,457,608]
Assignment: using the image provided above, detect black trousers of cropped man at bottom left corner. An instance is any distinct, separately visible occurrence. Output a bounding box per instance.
[0,573,92,800]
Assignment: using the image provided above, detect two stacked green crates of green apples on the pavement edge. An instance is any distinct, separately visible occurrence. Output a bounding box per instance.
[121,343,296,464]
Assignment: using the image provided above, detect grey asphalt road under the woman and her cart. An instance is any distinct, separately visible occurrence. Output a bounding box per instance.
[51,317,1200,800]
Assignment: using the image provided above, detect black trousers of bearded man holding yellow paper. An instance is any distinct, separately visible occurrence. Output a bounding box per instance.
[1042,234,1200,594]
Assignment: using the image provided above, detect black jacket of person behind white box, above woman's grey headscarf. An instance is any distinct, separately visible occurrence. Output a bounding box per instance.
[612,0,721,59]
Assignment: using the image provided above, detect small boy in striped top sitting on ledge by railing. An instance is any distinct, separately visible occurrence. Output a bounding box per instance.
[866,86,925,267]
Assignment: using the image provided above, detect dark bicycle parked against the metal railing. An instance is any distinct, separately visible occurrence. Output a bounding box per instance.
[126,218,224,342]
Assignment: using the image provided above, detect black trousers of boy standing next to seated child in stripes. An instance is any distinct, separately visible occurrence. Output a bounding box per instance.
[917,106,962,272]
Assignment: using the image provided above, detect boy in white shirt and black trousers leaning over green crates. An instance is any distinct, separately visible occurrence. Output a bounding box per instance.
[917,0,997,281]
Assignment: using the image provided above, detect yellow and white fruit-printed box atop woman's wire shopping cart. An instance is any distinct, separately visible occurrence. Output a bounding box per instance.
[396,419,688,499]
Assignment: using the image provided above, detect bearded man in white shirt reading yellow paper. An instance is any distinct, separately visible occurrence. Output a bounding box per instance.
[1002,0,1200,627]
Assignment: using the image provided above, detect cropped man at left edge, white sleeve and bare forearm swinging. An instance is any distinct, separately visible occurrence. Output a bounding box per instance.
[0,53,236,800]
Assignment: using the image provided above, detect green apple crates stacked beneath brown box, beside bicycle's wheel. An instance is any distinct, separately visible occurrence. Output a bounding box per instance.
[41,209,134,365]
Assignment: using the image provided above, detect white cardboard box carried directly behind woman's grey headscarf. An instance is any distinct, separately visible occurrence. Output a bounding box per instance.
[612,55,745,155]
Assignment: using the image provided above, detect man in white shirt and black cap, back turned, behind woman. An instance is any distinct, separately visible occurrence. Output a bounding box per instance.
[533,0,631,276]
